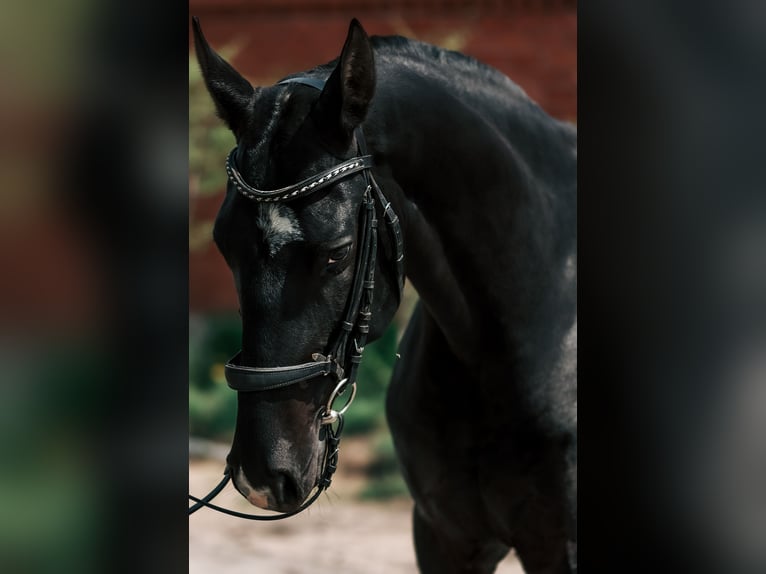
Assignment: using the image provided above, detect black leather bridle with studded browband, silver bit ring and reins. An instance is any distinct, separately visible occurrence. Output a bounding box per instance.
[189,77,404,520]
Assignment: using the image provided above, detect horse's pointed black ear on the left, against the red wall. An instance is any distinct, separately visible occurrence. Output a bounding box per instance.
[192,16,255,135]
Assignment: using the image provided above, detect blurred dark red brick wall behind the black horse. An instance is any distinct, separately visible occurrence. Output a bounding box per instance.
[189,0,577,316]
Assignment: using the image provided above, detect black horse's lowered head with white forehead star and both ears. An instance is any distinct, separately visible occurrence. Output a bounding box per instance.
[194,20,399,512]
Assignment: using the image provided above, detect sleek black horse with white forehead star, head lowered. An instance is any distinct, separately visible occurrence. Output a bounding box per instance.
[195,20,577,574]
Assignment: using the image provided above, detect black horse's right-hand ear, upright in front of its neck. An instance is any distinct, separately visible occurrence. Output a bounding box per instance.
[317,18,375,138]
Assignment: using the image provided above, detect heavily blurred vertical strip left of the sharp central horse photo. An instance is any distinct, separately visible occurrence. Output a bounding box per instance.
[0,0,188,574]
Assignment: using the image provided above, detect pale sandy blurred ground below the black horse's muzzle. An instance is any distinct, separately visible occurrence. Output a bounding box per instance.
[189,437,523,574]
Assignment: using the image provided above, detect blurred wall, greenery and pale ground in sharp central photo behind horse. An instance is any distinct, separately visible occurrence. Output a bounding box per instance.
[189,0,577,573]
